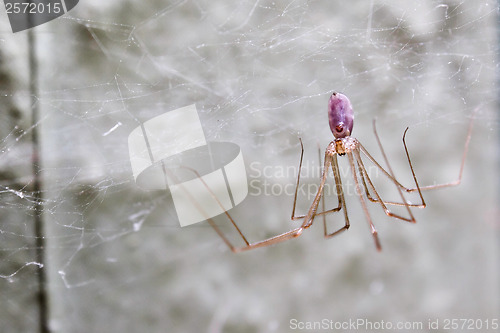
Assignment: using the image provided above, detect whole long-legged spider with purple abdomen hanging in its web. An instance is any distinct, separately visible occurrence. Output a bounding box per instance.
[191,92,473,252]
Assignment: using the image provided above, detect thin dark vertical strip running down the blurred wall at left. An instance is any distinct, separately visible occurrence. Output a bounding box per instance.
[28,29,49,333]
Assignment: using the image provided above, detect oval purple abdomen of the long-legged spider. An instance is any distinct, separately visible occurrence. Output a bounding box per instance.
[328,92,354,139]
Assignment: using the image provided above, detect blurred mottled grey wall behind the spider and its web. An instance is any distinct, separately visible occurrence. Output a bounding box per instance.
[0,0,500,332]
